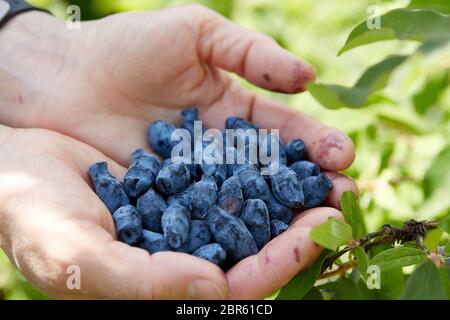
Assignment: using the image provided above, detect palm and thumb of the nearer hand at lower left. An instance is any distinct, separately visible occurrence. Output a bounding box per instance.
[0,126,228,299]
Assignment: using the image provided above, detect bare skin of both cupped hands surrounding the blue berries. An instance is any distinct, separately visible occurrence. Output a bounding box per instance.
[0,5,357,299]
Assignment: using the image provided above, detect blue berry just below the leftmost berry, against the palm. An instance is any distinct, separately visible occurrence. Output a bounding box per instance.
[113,205,142,245]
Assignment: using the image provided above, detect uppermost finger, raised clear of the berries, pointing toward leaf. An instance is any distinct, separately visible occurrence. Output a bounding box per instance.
[194,7,315,93]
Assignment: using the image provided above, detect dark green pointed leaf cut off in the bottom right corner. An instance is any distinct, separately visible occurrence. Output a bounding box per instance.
[401,259,447,300]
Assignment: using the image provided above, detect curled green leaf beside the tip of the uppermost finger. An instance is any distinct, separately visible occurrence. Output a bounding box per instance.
[308,56,408,109]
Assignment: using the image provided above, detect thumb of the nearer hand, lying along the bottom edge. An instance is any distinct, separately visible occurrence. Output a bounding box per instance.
[67,226,228,300]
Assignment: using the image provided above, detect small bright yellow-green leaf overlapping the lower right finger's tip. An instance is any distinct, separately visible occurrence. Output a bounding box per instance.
[309,218,353,251]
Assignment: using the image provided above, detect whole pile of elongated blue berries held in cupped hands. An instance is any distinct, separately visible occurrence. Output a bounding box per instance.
[89,108,333,269]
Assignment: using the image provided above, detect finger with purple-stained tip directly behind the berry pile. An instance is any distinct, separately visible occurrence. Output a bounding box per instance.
[201,82,355,171]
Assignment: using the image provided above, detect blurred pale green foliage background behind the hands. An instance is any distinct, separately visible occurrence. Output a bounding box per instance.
[0,0,450,299]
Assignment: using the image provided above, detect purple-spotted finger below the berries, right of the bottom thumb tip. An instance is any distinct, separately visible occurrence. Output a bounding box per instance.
[227,208,340,299]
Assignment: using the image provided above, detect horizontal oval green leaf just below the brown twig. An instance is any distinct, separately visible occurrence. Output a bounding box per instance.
[370,247,427,271]
